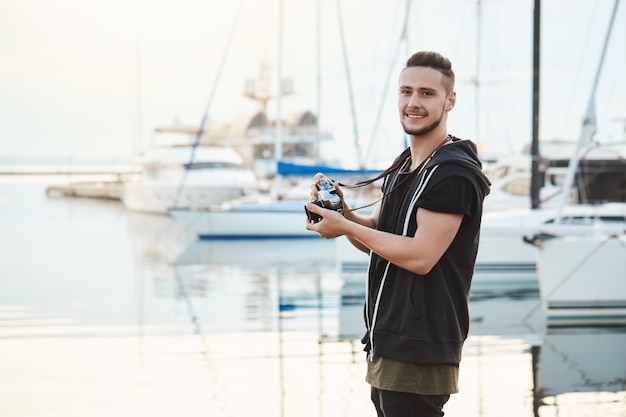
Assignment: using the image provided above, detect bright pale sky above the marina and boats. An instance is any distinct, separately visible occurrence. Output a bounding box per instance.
[0,0,626,166]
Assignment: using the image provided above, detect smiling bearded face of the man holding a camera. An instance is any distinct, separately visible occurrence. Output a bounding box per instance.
[398,67,456,136]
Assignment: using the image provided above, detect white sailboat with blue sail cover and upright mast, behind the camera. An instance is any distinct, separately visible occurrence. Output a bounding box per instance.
[169,0,380,240]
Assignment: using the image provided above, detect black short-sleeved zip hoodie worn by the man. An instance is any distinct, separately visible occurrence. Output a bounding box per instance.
[363,137,490,364]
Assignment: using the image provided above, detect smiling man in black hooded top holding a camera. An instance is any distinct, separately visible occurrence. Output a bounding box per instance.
[306,51,490,417]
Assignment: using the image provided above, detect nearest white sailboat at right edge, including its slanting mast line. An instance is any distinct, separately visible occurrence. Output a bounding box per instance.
[526,0,626,326]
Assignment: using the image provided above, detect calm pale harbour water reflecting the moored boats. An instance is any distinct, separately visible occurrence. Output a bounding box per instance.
[0,177,626,417]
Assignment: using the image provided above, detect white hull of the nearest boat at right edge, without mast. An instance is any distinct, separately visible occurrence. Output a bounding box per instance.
[532,203,626,326]
